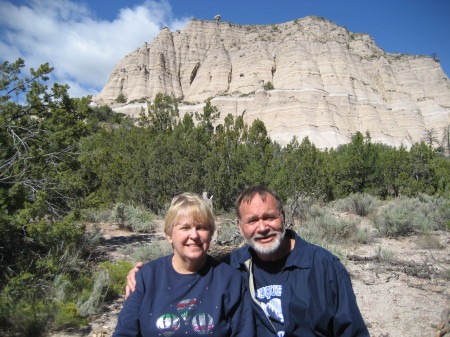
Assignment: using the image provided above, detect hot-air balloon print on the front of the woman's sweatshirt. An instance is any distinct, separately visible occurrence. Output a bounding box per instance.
[156,298,214,336]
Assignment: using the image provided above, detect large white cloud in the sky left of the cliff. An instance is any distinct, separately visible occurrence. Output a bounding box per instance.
[0,0,189,96]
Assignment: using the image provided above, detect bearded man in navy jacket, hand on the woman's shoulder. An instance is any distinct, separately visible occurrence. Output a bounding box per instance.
[127,186,369,337]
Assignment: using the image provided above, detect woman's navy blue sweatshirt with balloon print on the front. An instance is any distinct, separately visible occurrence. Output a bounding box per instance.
[113,255,255,337]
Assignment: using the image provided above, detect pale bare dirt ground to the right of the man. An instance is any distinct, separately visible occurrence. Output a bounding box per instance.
[347,233,450,337]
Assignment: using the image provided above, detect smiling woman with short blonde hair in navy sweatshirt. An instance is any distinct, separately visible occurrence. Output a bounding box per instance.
[113,193,254,337]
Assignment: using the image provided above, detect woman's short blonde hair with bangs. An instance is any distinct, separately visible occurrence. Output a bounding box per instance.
[164,192,216,236]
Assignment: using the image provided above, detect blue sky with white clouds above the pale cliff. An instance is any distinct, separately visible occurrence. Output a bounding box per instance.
[0,0,450,97]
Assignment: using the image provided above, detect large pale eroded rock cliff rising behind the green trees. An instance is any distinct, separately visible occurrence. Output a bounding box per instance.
[94,17,450,148]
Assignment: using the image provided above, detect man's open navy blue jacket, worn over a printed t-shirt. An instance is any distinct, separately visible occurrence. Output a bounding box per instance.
[226,230,369,337]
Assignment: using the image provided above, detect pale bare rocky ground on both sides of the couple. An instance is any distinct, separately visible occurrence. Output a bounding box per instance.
[52,220,450,337]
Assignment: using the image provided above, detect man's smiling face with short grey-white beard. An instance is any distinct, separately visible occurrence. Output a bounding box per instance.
[239,194,285,257]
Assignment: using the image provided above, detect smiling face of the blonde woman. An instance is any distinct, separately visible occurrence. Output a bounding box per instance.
[167,215,212,263]
